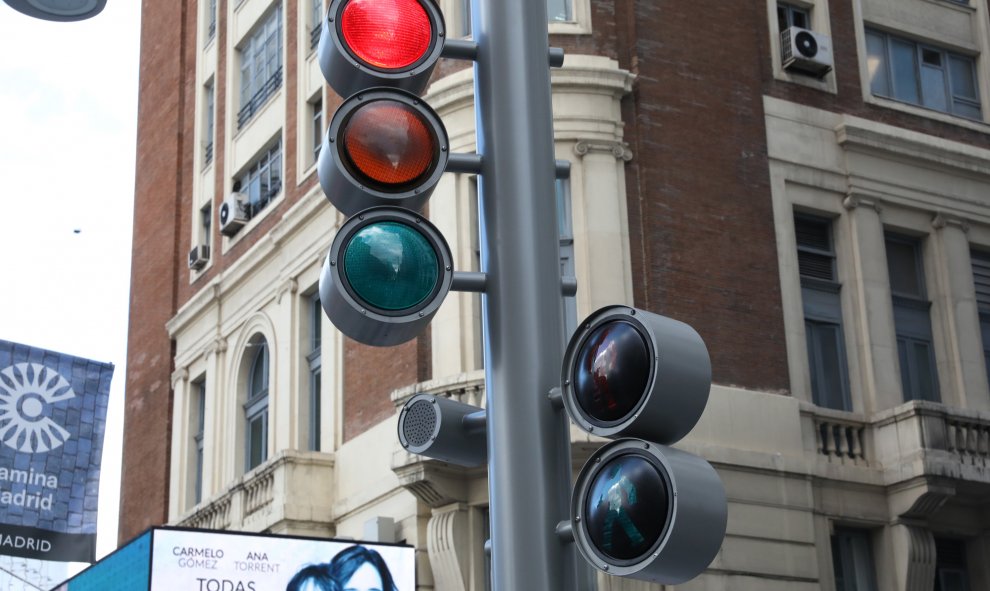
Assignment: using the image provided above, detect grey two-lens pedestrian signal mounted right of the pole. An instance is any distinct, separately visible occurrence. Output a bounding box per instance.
[561,306,727,584]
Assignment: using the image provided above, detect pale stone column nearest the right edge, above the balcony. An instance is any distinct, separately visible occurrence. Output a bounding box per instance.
[925,213,990,411]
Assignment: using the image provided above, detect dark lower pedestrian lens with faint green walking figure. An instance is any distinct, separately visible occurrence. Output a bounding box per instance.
[584,454,668,561]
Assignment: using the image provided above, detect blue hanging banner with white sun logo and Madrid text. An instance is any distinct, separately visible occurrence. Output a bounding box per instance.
[0,340,113,562]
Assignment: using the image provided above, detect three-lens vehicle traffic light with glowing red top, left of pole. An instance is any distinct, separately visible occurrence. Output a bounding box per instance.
[317,0,454,346]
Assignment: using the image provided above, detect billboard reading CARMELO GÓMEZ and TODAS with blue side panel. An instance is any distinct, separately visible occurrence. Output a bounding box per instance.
[56,528,416,591]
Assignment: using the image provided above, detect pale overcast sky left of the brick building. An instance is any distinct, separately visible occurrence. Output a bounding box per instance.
[0,0,141,588]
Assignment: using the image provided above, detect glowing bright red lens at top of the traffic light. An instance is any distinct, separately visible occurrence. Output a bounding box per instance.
[340,0,433,70]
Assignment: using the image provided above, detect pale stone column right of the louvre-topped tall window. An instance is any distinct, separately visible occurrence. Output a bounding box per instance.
[843,192,904,413]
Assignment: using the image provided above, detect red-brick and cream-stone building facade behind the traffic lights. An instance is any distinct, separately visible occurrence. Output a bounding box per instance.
[120,0,990,590]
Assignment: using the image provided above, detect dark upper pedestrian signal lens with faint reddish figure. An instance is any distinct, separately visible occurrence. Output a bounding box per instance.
[573,321,651,423]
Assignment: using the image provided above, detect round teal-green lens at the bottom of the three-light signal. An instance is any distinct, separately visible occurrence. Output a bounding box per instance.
[342,221,440,312]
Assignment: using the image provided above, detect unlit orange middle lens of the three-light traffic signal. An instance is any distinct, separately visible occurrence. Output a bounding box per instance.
[342,99,437,189]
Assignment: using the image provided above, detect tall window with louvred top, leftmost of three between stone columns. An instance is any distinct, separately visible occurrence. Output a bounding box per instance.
[794,215,852,410]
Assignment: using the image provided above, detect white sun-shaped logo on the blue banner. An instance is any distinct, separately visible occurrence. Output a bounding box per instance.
[0,363,76,453]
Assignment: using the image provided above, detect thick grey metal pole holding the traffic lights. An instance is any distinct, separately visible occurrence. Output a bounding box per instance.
[471,0,578,591]
